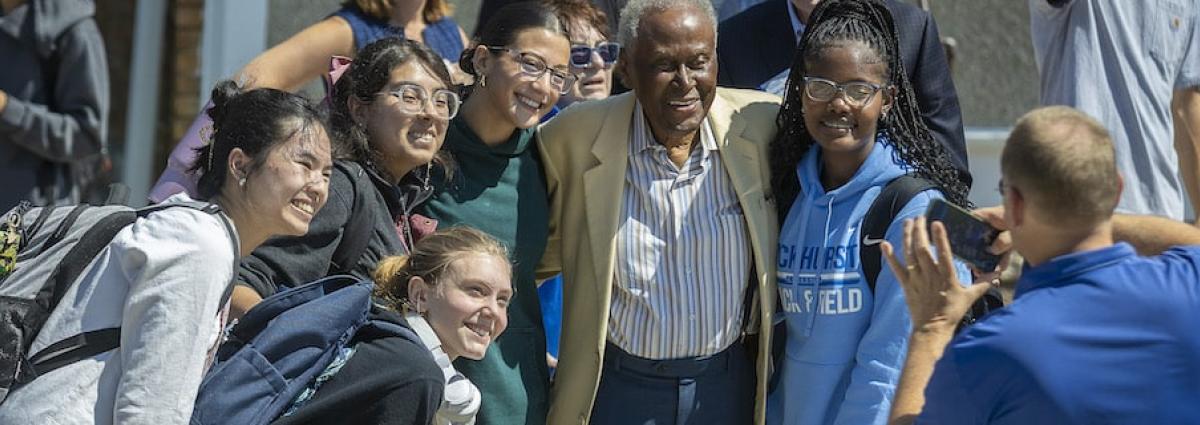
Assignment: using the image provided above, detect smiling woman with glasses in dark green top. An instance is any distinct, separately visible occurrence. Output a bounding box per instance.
[422,2,576,425]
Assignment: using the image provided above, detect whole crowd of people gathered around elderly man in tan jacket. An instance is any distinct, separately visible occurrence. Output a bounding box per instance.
[0,0,1200,425]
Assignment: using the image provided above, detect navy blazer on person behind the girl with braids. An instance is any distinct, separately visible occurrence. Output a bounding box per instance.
[716,0,971,186]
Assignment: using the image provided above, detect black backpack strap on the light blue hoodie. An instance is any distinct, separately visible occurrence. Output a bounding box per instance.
[858,174,937,294]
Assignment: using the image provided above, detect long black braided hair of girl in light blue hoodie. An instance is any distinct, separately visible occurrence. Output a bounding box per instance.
[770,0,970,212]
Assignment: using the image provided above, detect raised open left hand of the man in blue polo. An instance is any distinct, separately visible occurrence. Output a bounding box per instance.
[881,217,989,335]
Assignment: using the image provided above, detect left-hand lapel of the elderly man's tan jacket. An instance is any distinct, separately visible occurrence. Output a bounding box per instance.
[583,92,635,291]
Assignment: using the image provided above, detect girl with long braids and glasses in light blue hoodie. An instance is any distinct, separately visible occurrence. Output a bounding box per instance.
[768,0,970,424]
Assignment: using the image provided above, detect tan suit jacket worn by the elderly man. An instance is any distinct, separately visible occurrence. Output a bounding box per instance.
[538,89,779,425]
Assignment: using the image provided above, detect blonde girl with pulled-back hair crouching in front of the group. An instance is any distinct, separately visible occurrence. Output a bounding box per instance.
[278,227,512,425]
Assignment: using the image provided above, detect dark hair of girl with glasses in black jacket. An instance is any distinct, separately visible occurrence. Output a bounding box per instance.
[332,37,455,179]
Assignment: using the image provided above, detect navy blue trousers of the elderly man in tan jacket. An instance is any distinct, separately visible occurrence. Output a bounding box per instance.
[592,341,755,425]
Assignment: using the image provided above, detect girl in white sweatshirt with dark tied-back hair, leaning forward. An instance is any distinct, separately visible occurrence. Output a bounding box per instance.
[0,82,331,424]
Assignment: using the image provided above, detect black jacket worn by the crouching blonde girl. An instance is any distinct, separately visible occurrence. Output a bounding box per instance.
[275,307,445,425]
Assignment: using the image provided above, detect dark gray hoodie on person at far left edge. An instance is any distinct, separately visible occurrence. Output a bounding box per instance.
[0,0,109,211]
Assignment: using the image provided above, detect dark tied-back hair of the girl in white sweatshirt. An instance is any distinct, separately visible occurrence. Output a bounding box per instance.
[188,80,329,199]
